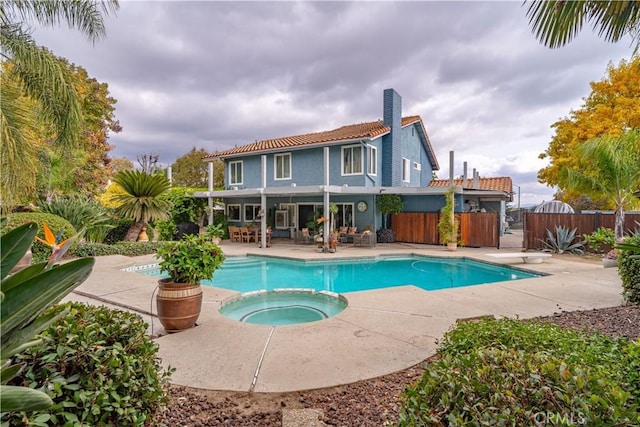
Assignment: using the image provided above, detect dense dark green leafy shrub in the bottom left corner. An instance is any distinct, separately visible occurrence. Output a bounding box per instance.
[5,303,170,426]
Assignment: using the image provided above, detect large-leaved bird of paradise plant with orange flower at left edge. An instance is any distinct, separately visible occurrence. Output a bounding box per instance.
[0,223,94,412]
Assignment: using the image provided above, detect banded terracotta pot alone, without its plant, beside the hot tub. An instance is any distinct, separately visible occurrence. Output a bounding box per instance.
[156,279,202,333]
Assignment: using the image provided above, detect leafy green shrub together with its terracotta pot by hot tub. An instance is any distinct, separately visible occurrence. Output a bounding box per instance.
[156,234,225,333]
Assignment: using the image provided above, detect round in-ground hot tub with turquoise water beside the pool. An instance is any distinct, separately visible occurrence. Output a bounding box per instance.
[220,289,348,326]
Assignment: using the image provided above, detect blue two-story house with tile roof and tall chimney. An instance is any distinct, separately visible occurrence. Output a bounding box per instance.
[196,89,511,247]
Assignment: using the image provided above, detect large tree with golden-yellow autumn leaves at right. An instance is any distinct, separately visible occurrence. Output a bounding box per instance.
[538,55,640,204]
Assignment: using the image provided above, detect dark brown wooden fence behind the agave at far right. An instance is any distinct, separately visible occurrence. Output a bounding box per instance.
[522,212,640,249]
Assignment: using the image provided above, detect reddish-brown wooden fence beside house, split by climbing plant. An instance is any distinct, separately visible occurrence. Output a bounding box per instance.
[391,212,500,248]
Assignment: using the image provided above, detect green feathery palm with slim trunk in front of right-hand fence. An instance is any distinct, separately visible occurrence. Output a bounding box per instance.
[567,130,640,243]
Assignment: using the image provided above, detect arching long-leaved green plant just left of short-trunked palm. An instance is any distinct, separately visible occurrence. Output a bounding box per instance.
[38,196,114,243]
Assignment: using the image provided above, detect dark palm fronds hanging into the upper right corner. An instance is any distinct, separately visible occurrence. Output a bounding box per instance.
[525,0,640,51]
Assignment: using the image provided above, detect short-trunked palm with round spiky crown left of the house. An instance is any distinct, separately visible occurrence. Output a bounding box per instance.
[112,170,171,242]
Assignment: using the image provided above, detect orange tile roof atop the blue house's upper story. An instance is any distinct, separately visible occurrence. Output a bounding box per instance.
[203,116,422,159]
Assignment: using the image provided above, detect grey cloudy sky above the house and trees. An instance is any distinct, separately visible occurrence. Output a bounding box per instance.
[33,0,633,206]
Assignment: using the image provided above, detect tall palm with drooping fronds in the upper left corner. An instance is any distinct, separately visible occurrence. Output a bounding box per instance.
[0,0,118,211]
